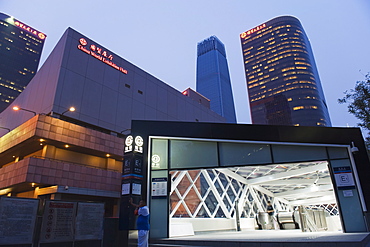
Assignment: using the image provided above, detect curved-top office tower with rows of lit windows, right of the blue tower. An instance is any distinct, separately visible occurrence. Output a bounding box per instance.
[240,16,331,126]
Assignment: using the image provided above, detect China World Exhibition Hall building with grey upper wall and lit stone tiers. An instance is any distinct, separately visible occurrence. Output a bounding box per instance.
[0,28,226,217]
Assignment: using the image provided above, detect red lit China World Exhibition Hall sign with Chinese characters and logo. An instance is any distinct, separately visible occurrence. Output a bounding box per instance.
[77,38,127,74]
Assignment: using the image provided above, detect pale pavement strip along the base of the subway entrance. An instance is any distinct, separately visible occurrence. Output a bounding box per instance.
[150,230,370,247]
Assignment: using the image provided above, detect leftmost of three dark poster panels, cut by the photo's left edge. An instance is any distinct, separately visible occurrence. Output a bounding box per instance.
[0,197,39,245]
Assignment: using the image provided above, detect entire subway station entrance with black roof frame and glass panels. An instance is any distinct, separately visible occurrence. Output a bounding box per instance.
[125,121,369,242]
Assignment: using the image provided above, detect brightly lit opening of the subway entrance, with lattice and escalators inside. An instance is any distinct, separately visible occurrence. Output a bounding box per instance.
[169,162,342,237]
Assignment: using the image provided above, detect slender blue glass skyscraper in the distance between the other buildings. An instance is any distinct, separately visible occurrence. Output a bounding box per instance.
[196,36,236,123]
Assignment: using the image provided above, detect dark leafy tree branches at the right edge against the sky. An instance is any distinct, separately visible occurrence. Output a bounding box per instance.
[338,73,370,150]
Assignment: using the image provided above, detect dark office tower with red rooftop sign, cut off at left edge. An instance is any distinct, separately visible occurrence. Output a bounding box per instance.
[0,13,46,112]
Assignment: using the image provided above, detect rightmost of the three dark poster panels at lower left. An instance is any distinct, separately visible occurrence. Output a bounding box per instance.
[75,202,104,240]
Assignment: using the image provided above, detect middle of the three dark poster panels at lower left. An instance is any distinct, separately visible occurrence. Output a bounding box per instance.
[40,201,77,243]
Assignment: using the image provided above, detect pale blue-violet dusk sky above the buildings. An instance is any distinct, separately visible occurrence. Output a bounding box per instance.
[0,0,370,127]
